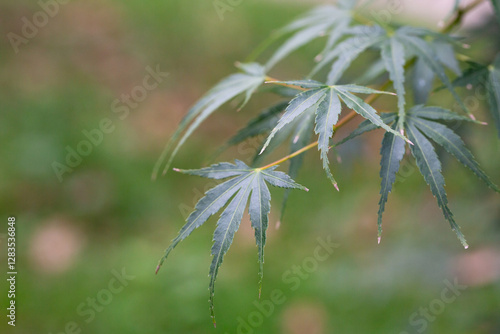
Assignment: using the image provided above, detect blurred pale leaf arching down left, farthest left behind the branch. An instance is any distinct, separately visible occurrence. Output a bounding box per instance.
[153,63,265,178]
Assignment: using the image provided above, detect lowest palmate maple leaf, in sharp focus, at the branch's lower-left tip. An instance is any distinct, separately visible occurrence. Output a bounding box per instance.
[156,160,308,325]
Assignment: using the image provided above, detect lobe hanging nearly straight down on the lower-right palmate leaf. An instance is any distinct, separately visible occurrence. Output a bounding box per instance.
[377,124,405,243]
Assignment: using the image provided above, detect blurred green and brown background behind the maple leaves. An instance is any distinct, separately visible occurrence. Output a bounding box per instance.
[0,0,500,334]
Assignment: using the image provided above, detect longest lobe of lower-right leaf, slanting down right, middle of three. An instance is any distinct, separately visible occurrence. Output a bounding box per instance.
[406,122,469,248]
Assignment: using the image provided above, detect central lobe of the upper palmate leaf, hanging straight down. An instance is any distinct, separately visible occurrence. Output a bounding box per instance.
[381,38,406,128]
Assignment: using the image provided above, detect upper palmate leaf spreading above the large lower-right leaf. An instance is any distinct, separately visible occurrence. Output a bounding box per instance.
[310,25,467,124]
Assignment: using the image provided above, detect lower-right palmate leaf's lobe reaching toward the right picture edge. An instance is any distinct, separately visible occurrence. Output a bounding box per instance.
[412,117,499,192]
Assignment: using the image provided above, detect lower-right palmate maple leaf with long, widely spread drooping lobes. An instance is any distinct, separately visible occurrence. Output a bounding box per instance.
[337,105,500,246]
